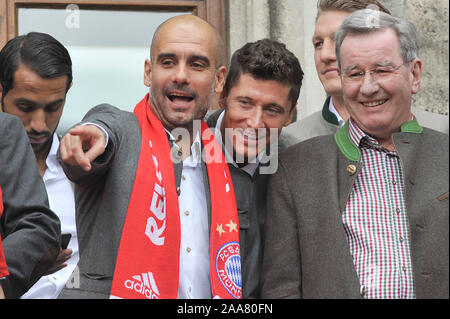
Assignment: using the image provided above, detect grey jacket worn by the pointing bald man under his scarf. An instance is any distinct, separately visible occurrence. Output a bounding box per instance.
[59,104,218,298]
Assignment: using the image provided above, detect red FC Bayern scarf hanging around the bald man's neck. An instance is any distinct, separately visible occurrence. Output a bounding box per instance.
[111,94,242,299]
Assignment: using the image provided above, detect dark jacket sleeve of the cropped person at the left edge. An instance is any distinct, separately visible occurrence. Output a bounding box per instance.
[0,112,61,298]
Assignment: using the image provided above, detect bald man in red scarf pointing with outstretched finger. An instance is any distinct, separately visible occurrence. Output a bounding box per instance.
[59,15,242,299]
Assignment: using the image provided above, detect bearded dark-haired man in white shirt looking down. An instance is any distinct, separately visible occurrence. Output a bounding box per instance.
[0,32,78,299]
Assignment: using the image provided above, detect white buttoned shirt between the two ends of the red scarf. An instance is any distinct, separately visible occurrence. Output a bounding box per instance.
[169,132,211,299]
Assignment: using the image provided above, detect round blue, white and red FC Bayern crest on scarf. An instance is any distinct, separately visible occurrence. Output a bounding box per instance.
[216,242,242,299]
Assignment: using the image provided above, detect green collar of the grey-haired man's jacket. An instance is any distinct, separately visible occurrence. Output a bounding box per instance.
[334,119,423,162]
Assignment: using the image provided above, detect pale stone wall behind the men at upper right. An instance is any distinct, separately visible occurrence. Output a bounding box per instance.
[228,0,449,118]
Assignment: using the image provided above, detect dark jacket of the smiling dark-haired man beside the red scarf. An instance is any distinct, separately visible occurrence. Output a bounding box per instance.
[207,110,297,298]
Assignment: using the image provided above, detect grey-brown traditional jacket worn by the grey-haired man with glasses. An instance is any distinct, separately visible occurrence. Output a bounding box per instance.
[262,122,449,298]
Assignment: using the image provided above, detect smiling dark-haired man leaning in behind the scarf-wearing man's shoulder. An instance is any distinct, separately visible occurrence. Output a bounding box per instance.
[207,39,303,298]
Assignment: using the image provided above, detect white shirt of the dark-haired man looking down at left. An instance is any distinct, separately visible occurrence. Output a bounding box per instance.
[21,133,79,299]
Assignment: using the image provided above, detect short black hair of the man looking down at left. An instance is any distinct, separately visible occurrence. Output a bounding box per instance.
[0,32,72,98]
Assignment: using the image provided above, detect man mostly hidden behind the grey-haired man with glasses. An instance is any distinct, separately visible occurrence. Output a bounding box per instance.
[285,0,449,141]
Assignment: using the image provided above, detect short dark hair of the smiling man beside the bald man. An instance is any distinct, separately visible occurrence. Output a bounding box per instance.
[222,39,303,110]
